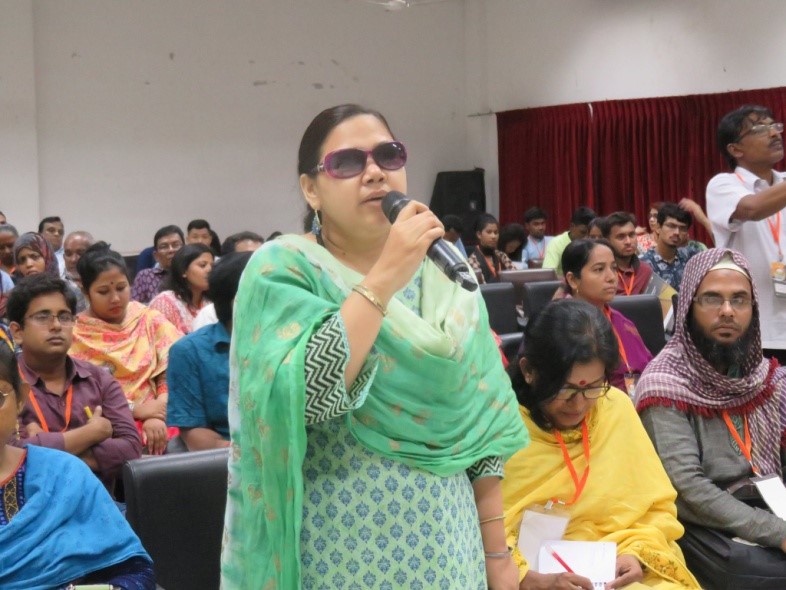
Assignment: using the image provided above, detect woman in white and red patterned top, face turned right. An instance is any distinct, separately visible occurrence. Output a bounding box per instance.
[150,243,214,334]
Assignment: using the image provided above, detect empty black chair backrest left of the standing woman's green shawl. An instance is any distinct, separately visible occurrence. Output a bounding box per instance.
[123,449,229,590]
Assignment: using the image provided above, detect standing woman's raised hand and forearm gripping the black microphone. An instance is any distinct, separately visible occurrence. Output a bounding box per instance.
[363,201,445,303]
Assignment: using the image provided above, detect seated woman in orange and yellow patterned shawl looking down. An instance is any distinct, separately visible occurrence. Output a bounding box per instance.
[69,242,182,455]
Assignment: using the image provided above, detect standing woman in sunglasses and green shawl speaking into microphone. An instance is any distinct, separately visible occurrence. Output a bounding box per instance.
[222,105,528,590]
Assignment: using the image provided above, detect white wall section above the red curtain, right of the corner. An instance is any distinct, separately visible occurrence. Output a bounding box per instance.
[468,0,786,215]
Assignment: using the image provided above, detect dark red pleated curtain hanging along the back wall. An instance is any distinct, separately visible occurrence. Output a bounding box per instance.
[497,88,786,240]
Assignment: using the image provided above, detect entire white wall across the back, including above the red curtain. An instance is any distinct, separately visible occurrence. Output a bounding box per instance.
[9,0,786,251]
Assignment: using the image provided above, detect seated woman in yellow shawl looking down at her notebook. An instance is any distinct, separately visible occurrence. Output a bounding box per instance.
[502,300,699,590]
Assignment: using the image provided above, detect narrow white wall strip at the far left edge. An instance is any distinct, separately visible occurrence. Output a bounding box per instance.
[0,0,39,235]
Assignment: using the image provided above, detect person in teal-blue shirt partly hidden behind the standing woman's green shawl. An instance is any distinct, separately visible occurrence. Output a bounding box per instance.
[167,252,251,451]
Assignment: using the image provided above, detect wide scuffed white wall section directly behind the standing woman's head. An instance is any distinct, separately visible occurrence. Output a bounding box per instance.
[23,0,467,251]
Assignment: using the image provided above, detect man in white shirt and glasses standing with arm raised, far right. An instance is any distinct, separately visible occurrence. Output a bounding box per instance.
[707,105,786,363]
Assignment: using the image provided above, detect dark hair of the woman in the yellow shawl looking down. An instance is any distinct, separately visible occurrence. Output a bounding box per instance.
[509,300,619,430]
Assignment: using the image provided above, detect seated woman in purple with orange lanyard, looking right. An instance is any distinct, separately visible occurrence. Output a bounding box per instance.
[562,238,652,397]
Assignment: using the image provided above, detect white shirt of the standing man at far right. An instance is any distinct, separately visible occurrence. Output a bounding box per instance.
[707,166,786,349]
